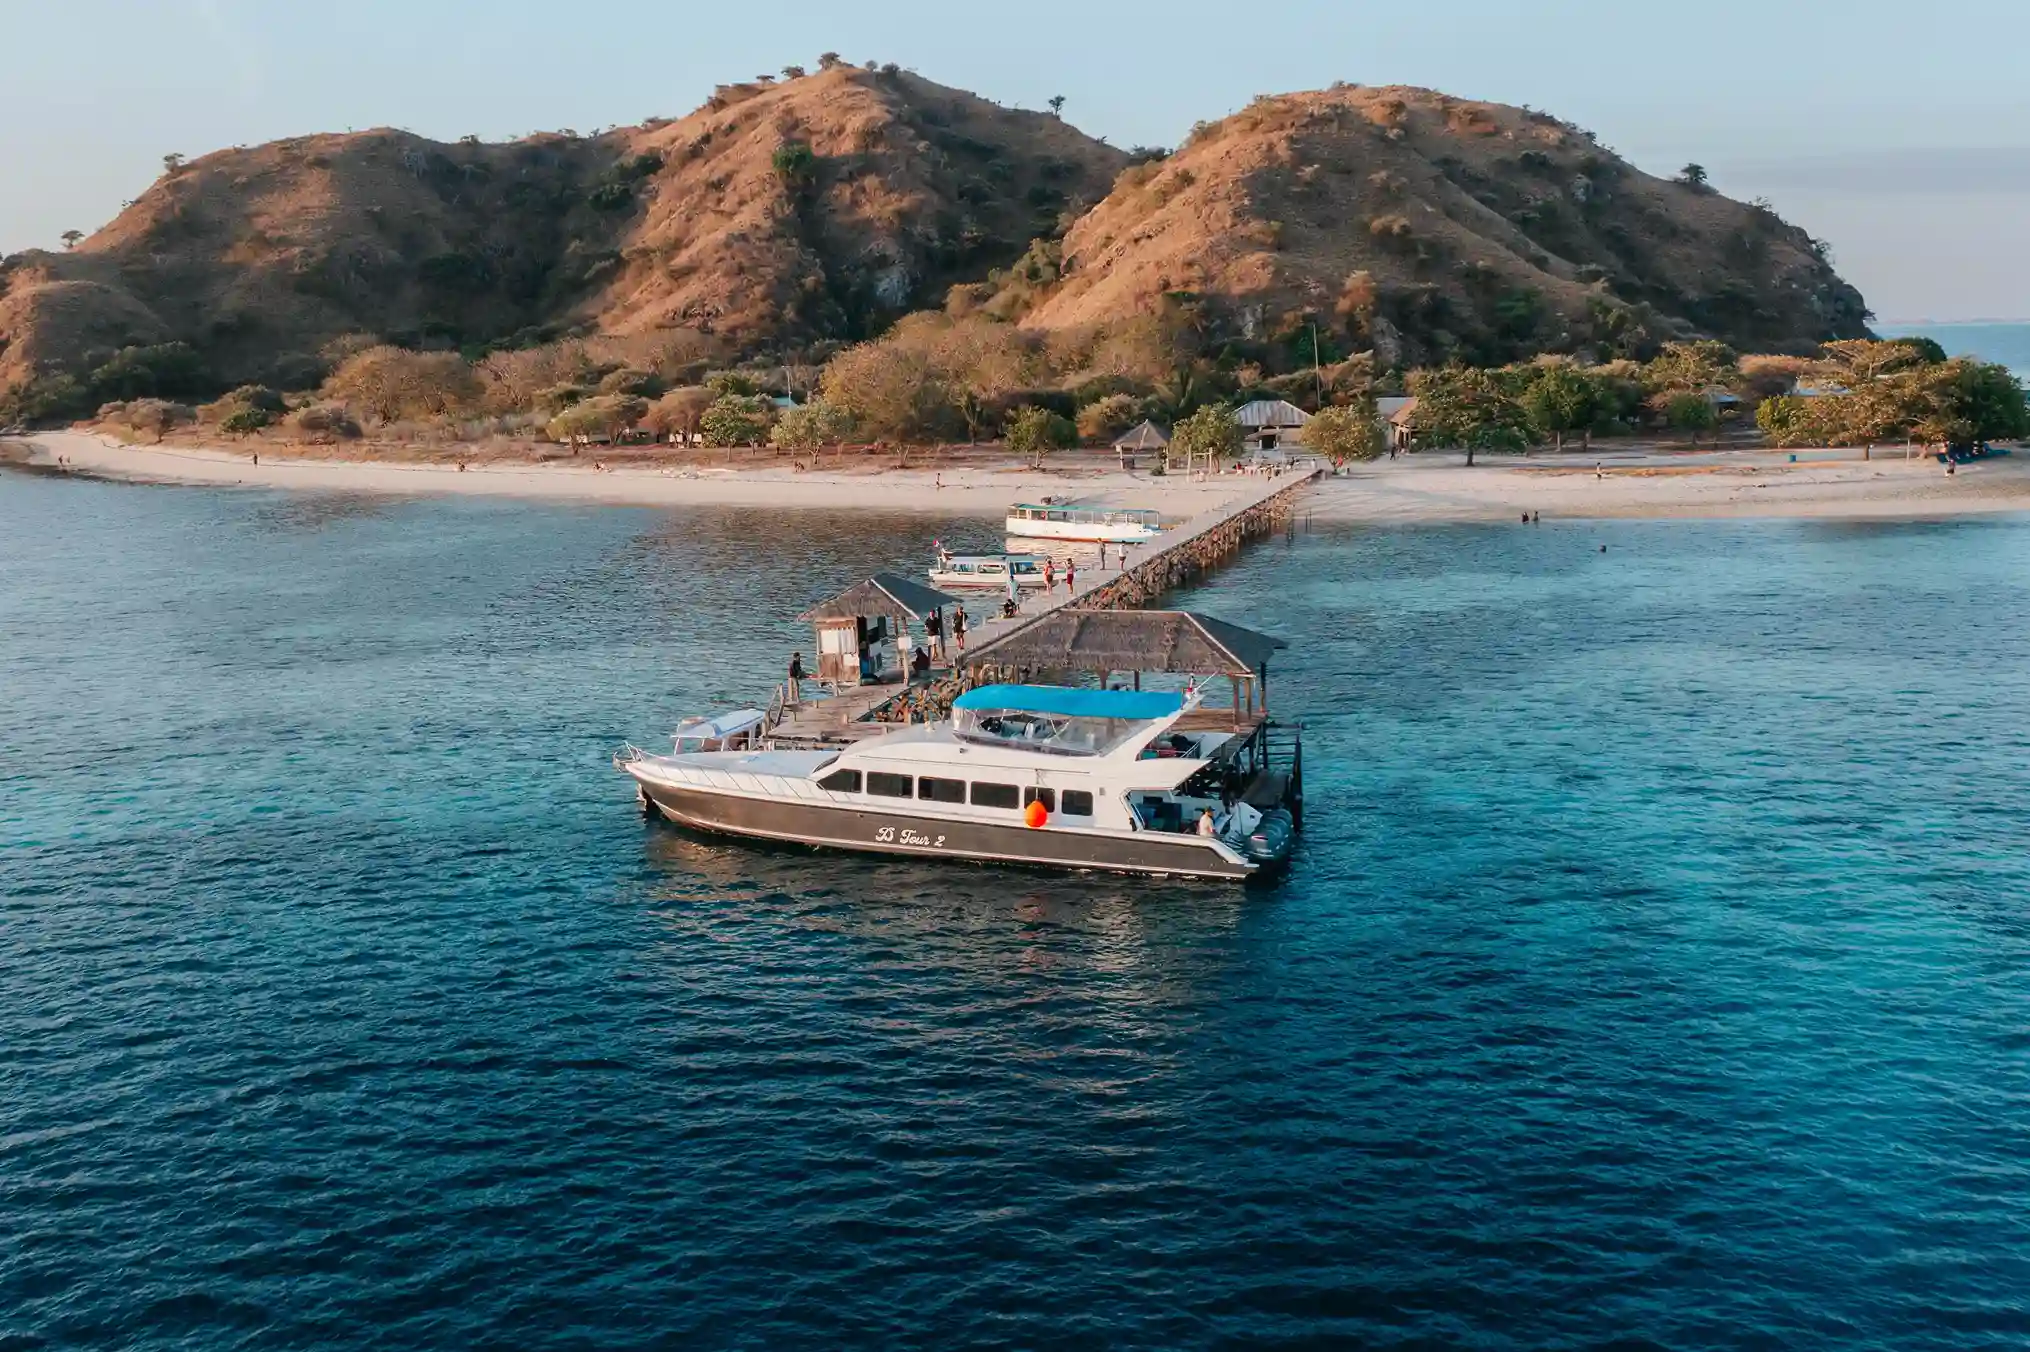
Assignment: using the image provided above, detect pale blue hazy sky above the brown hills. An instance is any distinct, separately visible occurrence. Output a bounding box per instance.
[0,0,2030,319]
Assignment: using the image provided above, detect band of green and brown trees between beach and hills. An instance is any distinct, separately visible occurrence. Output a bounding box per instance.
[0,316,2030,471]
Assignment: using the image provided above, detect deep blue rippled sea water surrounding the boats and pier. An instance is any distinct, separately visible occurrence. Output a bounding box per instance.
[0,468,2030,1348]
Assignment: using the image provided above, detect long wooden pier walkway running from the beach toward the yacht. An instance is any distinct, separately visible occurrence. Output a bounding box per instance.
[771,469,1322,745]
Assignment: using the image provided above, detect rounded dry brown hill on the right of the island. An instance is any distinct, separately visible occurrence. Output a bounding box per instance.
[1025,87,1866,365]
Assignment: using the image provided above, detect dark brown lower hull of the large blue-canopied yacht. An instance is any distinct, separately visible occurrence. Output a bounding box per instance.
[639,780,1257,881]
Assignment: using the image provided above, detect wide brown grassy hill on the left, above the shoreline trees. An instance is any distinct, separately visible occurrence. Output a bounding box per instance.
[0,65,1127,390]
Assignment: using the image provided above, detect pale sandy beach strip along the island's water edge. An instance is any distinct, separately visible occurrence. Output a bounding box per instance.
[0,432,2030,524]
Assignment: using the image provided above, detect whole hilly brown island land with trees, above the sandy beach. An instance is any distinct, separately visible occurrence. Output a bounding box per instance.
[0,53,2030,459]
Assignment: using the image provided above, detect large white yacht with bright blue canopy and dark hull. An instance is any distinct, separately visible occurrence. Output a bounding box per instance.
[615,686,1295,879]
